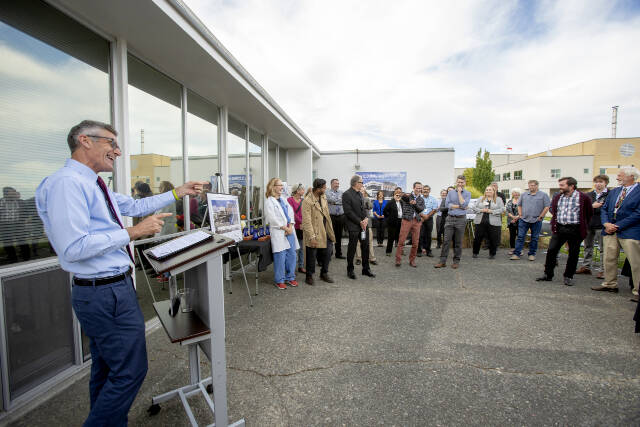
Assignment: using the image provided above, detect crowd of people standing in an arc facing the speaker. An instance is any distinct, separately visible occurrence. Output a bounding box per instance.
[265,168,640,300]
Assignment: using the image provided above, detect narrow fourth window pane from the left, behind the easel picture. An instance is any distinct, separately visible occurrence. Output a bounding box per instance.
[227,116,247,215]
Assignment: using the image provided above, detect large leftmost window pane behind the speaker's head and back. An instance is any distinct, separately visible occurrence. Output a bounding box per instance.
[0,2,111,265]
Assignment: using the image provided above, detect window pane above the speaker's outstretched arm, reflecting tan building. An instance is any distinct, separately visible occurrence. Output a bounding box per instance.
[127,55,184,234]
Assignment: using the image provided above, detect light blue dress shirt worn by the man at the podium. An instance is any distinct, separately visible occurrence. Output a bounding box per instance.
[36,159,175,279]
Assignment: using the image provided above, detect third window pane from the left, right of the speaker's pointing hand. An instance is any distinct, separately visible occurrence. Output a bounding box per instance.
[186,91,219,231]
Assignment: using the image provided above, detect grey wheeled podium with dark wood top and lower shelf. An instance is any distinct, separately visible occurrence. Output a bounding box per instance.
[143,234,244,427]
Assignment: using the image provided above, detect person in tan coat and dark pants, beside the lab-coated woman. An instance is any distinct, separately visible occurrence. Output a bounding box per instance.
[302,178,336,285]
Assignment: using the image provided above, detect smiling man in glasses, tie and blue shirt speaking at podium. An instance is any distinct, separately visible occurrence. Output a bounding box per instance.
[36,120,204,426]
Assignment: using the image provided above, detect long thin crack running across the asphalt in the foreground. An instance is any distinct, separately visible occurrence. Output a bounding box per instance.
[227,358,640,385]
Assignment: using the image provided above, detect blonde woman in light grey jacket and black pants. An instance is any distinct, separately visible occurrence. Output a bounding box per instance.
[473,186,504,259]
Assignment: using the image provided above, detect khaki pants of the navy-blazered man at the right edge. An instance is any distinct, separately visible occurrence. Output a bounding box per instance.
[602,234,640,295]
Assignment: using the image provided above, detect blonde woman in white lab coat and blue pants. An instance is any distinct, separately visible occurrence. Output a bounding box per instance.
[264,178,300,289]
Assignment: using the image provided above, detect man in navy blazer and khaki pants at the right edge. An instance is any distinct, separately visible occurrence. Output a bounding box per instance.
[591,167,640,295]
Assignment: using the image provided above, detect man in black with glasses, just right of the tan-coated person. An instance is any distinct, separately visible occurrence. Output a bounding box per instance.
[342,175,376,279]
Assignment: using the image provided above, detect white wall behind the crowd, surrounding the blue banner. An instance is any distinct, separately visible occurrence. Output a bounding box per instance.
[314,149,455,193]
